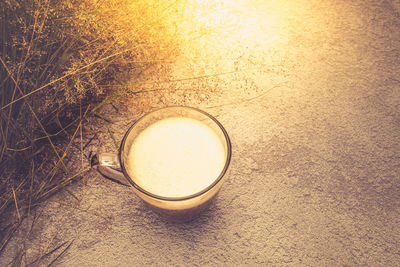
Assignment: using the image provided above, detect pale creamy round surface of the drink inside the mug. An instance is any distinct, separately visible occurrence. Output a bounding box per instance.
[127,117,226,197]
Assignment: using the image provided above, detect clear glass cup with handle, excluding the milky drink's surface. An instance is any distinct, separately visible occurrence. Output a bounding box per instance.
[92,106,232,221]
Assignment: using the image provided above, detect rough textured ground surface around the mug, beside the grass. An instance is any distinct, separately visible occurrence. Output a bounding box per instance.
[0,0,400,266]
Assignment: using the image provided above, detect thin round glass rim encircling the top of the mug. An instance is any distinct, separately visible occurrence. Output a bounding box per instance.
[118,106,232,201]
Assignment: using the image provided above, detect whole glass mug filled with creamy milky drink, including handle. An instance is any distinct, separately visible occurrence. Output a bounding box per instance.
[92,106,232,222]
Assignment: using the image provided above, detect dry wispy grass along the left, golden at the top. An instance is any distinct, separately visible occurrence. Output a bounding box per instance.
[0,0,183,265]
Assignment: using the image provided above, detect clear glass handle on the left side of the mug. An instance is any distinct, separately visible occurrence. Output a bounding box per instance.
[90,153,129,186]
